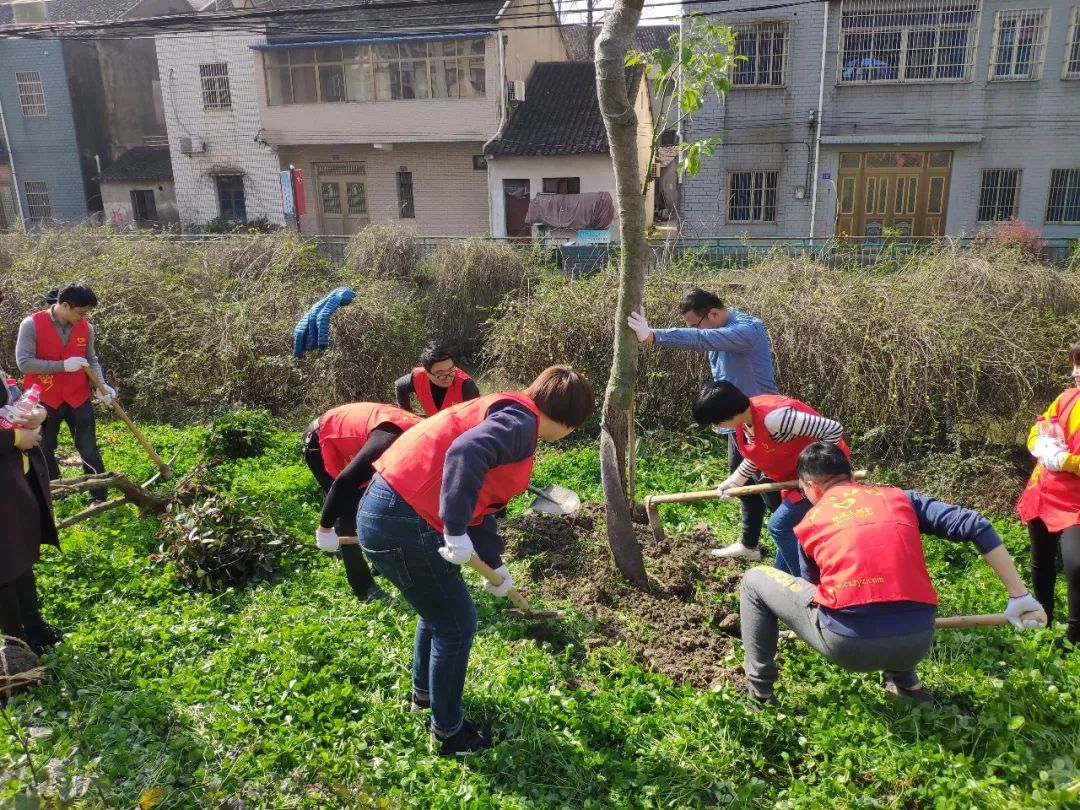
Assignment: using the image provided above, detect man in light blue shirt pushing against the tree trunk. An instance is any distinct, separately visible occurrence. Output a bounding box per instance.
[627,287,780,561]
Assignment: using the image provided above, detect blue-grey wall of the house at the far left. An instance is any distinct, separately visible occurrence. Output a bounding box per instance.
[0,38,86,221]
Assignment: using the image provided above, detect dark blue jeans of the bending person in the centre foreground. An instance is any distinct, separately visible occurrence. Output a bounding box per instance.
[356,475,476,737]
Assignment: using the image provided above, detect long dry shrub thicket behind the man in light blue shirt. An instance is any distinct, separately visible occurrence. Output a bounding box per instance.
[487,244,1080,457]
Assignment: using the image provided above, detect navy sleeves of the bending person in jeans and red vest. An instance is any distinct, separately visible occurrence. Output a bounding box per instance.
[438,401,537,568]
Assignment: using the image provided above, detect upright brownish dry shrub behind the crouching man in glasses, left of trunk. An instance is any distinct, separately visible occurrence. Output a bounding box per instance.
[423,239,531,356]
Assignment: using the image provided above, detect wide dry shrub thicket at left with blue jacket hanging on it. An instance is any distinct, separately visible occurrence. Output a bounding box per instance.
[0,229,427,419]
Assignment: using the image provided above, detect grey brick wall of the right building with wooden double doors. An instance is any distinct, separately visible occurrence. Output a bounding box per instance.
[683,0,1080,237]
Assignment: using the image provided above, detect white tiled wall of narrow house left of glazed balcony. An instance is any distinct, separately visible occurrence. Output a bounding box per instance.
[157,31,284,228]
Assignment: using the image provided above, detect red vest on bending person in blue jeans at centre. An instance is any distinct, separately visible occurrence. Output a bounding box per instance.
[375,392,540,531]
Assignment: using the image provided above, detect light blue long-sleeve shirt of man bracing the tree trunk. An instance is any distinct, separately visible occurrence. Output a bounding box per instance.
[652,309,777,396]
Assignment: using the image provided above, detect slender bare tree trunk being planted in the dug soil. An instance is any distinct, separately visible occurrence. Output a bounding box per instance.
[596,0,648,586]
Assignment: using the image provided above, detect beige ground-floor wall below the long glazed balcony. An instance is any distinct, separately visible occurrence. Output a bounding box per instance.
[281,141,488,237]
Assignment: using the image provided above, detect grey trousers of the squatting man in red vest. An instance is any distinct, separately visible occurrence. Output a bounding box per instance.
[740,566,934,696]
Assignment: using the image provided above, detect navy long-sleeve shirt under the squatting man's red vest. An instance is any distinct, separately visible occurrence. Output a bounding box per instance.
[799,489,1001,638]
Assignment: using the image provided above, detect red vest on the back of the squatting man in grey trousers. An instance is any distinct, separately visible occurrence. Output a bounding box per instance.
[795,484,937,609]
